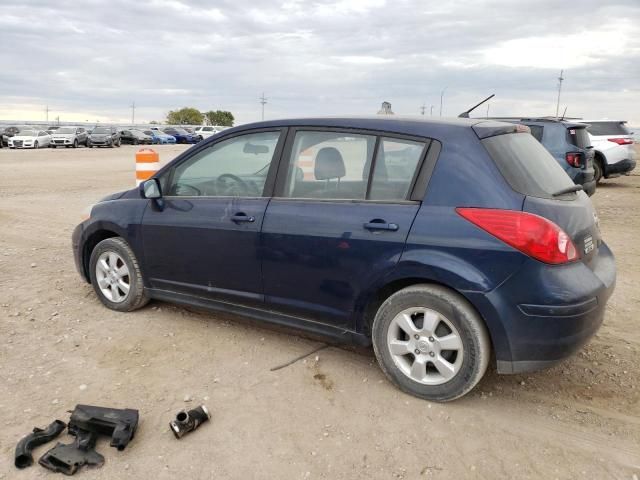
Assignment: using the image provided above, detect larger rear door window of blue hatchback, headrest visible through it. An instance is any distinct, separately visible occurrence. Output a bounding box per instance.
[284,131,376,199]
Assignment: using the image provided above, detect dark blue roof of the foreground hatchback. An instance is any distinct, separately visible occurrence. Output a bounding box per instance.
[224,115,513,139]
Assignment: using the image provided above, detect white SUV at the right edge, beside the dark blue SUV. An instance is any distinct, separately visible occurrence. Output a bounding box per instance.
[580,120,636,182]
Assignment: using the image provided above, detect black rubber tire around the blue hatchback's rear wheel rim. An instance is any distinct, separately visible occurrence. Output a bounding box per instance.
[372,284,491,402]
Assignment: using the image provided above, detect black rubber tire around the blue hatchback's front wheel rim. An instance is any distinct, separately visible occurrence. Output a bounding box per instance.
[89,237,149,312]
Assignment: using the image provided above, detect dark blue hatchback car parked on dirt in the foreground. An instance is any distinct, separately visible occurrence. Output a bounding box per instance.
[73,117,616,401]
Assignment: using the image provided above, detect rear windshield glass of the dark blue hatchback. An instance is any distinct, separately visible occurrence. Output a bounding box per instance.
[482,133,573,198]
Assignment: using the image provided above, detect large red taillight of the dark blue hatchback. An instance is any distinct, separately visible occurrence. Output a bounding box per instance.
[456,208,578,264]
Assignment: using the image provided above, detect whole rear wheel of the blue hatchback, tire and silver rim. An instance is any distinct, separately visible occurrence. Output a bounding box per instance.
[372,284,491,402]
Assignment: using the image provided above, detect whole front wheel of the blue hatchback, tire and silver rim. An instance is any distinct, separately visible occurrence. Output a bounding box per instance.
[89,237,149,312]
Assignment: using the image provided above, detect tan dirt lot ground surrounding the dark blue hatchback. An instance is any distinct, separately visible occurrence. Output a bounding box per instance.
[0,146,640,480]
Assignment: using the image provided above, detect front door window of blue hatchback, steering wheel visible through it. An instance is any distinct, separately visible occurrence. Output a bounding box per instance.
[167,132,280,197]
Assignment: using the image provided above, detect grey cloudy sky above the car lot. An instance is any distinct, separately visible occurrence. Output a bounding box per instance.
[0,0,640,125]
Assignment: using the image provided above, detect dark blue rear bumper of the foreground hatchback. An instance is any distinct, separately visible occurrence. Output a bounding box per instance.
[468,243,616,373]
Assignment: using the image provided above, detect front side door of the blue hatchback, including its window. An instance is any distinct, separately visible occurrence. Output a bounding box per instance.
[142,129,284,304]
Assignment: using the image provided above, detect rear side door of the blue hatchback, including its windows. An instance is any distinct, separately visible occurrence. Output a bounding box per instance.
[262,129,429,328]
